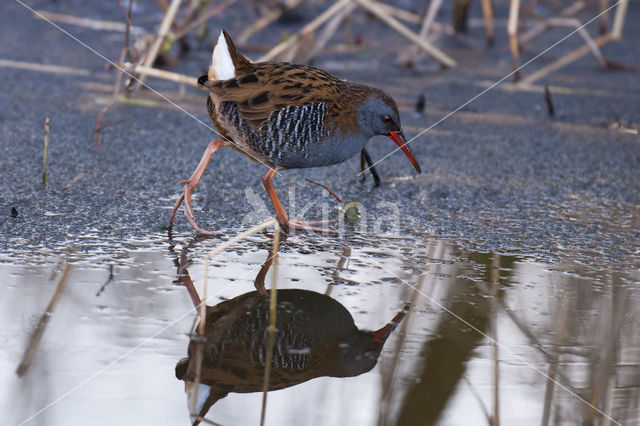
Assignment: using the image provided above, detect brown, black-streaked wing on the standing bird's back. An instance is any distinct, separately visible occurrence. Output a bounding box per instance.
[207,62,344,131]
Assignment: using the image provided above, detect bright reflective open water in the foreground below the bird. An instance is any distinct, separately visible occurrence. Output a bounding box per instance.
[0,234,640,425]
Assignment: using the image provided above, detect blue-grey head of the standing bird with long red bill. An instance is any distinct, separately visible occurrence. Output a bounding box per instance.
[357,88,422,173]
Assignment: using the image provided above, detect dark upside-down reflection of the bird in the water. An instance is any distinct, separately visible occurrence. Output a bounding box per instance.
[176,289,407,424]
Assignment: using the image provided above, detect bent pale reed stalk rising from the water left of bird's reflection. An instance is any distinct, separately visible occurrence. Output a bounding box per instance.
[189,218,280,416]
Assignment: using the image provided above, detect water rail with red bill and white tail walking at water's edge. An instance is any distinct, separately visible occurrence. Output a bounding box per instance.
[169,30,421,235]
